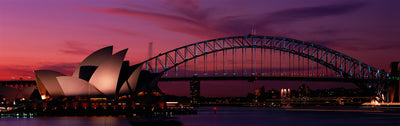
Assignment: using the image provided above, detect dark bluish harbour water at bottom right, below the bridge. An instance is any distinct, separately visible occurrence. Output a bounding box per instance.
[178,107,400,126]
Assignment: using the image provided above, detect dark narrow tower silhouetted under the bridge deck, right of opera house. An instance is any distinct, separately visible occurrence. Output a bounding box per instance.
[190,77,200,106]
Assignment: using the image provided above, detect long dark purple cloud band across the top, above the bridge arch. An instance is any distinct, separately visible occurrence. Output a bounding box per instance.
[86,0,365,37]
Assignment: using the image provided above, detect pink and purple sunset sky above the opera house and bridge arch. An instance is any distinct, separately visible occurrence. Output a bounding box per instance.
[0,0,400,96]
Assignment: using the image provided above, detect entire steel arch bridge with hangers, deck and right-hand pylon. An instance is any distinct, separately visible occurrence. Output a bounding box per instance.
[1,35,399,102]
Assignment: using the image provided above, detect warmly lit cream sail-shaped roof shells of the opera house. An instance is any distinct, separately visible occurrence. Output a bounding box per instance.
[34,46,142,98]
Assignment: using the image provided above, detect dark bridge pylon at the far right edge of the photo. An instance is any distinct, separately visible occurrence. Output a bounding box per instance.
[387,62,400,102]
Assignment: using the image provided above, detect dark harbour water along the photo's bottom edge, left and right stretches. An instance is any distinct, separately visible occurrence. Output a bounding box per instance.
[0,107,400,126]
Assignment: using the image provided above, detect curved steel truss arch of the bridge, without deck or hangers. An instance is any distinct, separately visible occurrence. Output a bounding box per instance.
[142,36,389,80]
